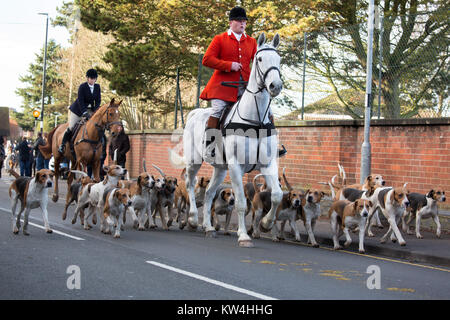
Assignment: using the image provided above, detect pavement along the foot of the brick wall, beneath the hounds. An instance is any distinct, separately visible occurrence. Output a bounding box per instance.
[1,172,450,267]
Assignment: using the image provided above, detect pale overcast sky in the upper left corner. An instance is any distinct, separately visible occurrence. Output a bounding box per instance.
[0,0,69,108]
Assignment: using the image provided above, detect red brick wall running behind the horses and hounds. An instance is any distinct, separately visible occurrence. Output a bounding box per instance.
[123,119,450,208]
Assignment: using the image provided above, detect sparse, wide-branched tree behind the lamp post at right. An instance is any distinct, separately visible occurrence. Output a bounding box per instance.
[288,0,449,118]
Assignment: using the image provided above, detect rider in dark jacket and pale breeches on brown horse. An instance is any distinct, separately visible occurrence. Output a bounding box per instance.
[58,69,101,154]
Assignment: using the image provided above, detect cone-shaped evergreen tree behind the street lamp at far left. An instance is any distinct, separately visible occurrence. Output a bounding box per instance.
[13,40,64,130]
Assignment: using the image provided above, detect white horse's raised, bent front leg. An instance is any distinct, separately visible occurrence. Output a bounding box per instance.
[259,161,283,232]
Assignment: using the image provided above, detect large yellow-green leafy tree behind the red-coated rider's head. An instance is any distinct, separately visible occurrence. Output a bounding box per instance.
[70,0,333,104]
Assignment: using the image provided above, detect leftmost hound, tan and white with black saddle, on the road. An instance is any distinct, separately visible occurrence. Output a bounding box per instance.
[9,169,54,236]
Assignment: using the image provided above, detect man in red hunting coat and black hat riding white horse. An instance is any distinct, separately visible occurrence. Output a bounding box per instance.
[200,7,285,161]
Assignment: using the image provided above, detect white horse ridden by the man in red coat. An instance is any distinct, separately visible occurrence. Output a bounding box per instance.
[171,33,283,247]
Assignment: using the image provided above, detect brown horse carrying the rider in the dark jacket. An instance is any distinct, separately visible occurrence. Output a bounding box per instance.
[39,99,122,202]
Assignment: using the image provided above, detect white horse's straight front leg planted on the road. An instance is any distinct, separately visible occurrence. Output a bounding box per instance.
[228,163,253,247]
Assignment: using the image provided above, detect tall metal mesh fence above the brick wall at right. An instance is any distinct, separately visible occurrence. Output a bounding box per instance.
[279,10,450,120]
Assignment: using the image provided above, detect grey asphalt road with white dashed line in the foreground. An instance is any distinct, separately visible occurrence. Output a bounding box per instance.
[0,178,450,300]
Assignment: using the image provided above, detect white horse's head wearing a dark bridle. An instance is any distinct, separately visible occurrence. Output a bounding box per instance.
[255,32,283,97]
